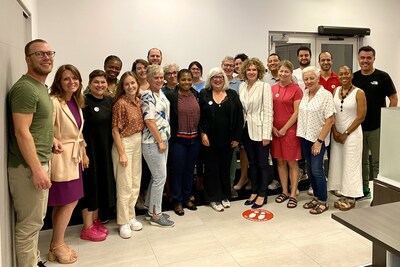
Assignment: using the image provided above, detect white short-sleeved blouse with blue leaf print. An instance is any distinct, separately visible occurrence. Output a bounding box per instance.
[141,90,171,144]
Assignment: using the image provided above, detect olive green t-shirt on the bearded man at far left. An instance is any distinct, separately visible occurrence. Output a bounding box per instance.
[7,75,54,168]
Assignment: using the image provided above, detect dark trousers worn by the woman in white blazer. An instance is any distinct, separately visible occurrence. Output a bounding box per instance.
[242,126,272,197]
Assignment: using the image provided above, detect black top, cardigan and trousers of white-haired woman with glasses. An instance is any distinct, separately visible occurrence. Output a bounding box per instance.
[199,88,243,202]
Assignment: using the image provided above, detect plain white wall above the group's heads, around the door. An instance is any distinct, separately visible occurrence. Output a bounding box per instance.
[38,0,400,88]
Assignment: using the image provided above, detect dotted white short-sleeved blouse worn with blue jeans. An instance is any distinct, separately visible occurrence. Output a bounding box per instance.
[297,86,335,146]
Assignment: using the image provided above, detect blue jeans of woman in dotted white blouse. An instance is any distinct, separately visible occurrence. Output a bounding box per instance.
[300,138,328,202]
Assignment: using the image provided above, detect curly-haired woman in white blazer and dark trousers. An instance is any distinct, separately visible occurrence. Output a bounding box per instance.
[239,58,273,209]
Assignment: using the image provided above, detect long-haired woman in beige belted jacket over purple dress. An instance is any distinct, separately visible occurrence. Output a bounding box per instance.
[48,65,88,264]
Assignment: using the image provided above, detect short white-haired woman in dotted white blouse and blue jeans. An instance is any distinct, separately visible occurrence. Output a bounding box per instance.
[297,67,335,214]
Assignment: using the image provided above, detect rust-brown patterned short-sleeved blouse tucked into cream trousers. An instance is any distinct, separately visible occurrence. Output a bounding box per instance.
[112,95,144,137]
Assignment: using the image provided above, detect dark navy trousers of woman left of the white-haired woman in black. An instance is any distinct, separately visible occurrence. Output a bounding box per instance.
[168,138,200,206]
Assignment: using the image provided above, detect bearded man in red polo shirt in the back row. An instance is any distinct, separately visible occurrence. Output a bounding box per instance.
[318,52,342,94]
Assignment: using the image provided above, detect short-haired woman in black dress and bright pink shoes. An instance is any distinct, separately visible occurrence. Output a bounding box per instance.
[81,70,115,241]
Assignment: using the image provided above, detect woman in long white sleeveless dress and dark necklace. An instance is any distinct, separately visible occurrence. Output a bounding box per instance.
[328,66,367,211]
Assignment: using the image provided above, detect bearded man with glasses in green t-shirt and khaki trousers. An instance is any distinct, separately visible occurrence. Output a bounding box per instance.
[7,39,55,267]
